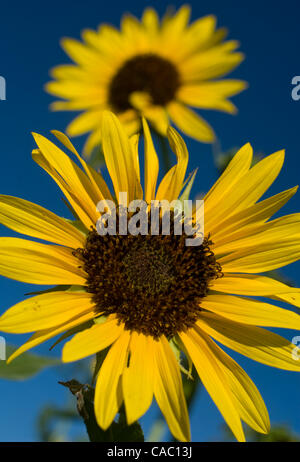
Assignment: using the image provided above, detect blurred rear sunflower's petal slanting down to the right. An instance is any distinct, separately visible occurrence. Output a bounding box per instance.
[168,102,215,143]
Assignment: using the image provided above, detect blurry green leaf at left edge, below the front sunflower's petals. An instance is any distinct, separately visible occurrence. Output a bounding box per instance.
[0,345,61,380]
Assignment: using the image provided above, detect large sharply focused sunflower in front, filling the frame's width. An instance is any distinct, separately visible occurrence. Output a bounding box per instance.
[0,113,300,441]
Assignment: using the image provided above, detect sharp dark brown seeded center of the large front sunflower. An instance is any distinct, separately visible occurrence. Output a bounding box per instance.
[76,217,222,338]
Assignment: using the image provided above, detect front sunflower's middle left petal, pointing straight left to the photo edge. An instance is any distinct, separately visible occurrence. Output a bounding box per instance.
[0,237,86,285]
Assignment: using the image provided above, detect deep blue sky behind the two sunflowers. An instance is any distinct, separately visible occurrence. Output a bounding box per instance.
[0,0,300,441]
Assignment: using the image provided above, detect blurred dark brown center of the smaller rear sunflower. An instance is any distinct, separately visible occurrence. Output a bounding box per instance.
[108,54,180,112]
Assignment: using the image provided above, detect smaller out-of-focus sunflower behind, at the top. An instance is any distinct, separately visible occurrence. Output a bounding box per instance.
[46,6,246,156]
